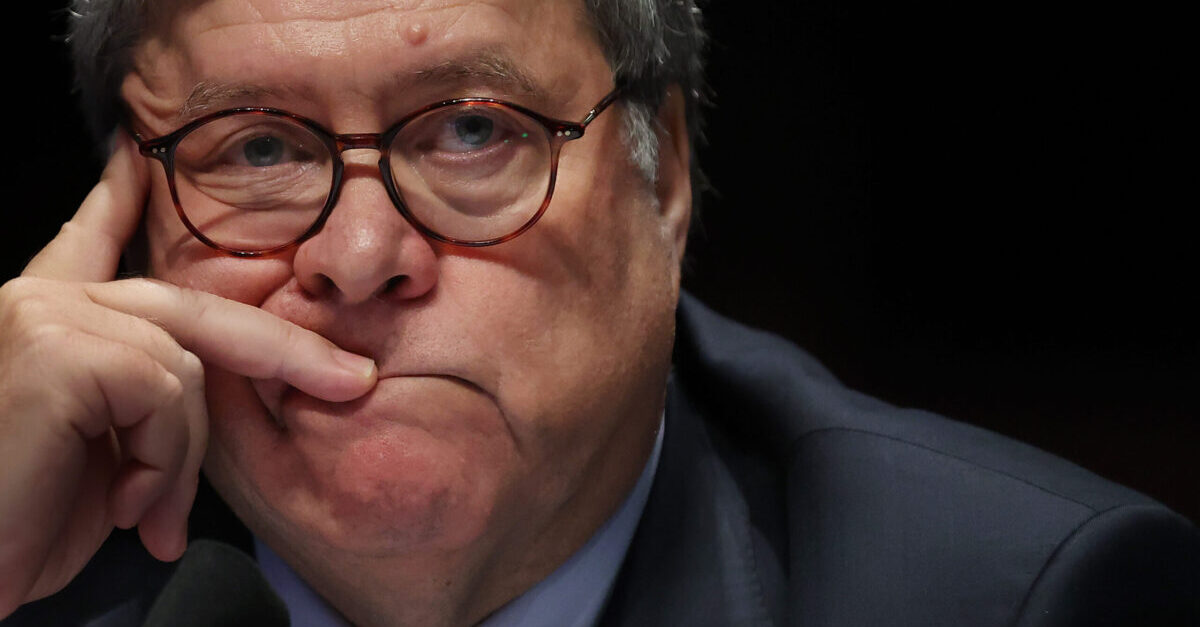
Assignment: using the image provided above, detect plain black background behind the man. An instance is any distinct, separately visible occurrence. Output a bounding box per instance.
[11,0,1200,520]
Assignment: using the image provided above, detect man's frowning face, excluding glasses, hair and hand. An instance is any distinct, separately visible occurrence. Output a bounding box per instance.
[124,0,690,598]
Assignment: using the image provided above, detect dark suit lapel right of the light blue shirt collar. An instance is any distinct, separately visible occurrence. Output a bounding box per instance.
[599,374,782,627]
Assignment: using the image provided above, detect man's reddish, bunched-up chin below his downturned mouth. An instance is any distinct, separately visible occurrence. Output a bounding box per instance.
[205,367,520,559]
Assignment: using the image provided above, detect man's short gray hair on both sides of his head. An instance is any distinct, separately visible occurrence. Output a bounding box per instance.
[67,0,706,192]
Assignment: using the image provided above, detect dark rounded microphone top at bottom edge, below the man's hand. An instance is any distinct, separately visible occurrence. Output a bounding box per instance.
[144,539,290,627]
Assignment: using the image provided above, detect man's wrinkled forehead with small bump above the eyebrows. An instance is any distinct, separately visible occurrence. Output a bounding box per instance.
[136,0,611,123]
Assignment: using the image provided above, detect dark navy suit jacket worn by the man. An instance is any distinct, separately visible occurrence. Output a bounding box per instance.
[4,295,1200,627]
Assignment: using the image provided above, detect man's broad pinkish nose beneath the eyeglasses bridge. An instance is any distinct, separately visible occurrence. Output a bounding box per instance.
[292,152,438,304]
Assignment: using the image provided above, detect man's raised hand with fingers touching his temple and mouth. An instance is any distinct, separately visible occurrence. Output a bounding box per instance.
[0,135,377,619]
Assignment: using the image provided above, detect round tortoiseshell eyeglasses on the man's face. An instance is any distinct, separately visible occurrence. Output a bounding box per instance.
[136,89,619,257]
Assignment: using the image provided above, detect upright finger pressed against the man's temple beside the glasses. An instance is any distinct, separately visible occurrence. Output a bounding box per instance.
[22,131,150,281]
